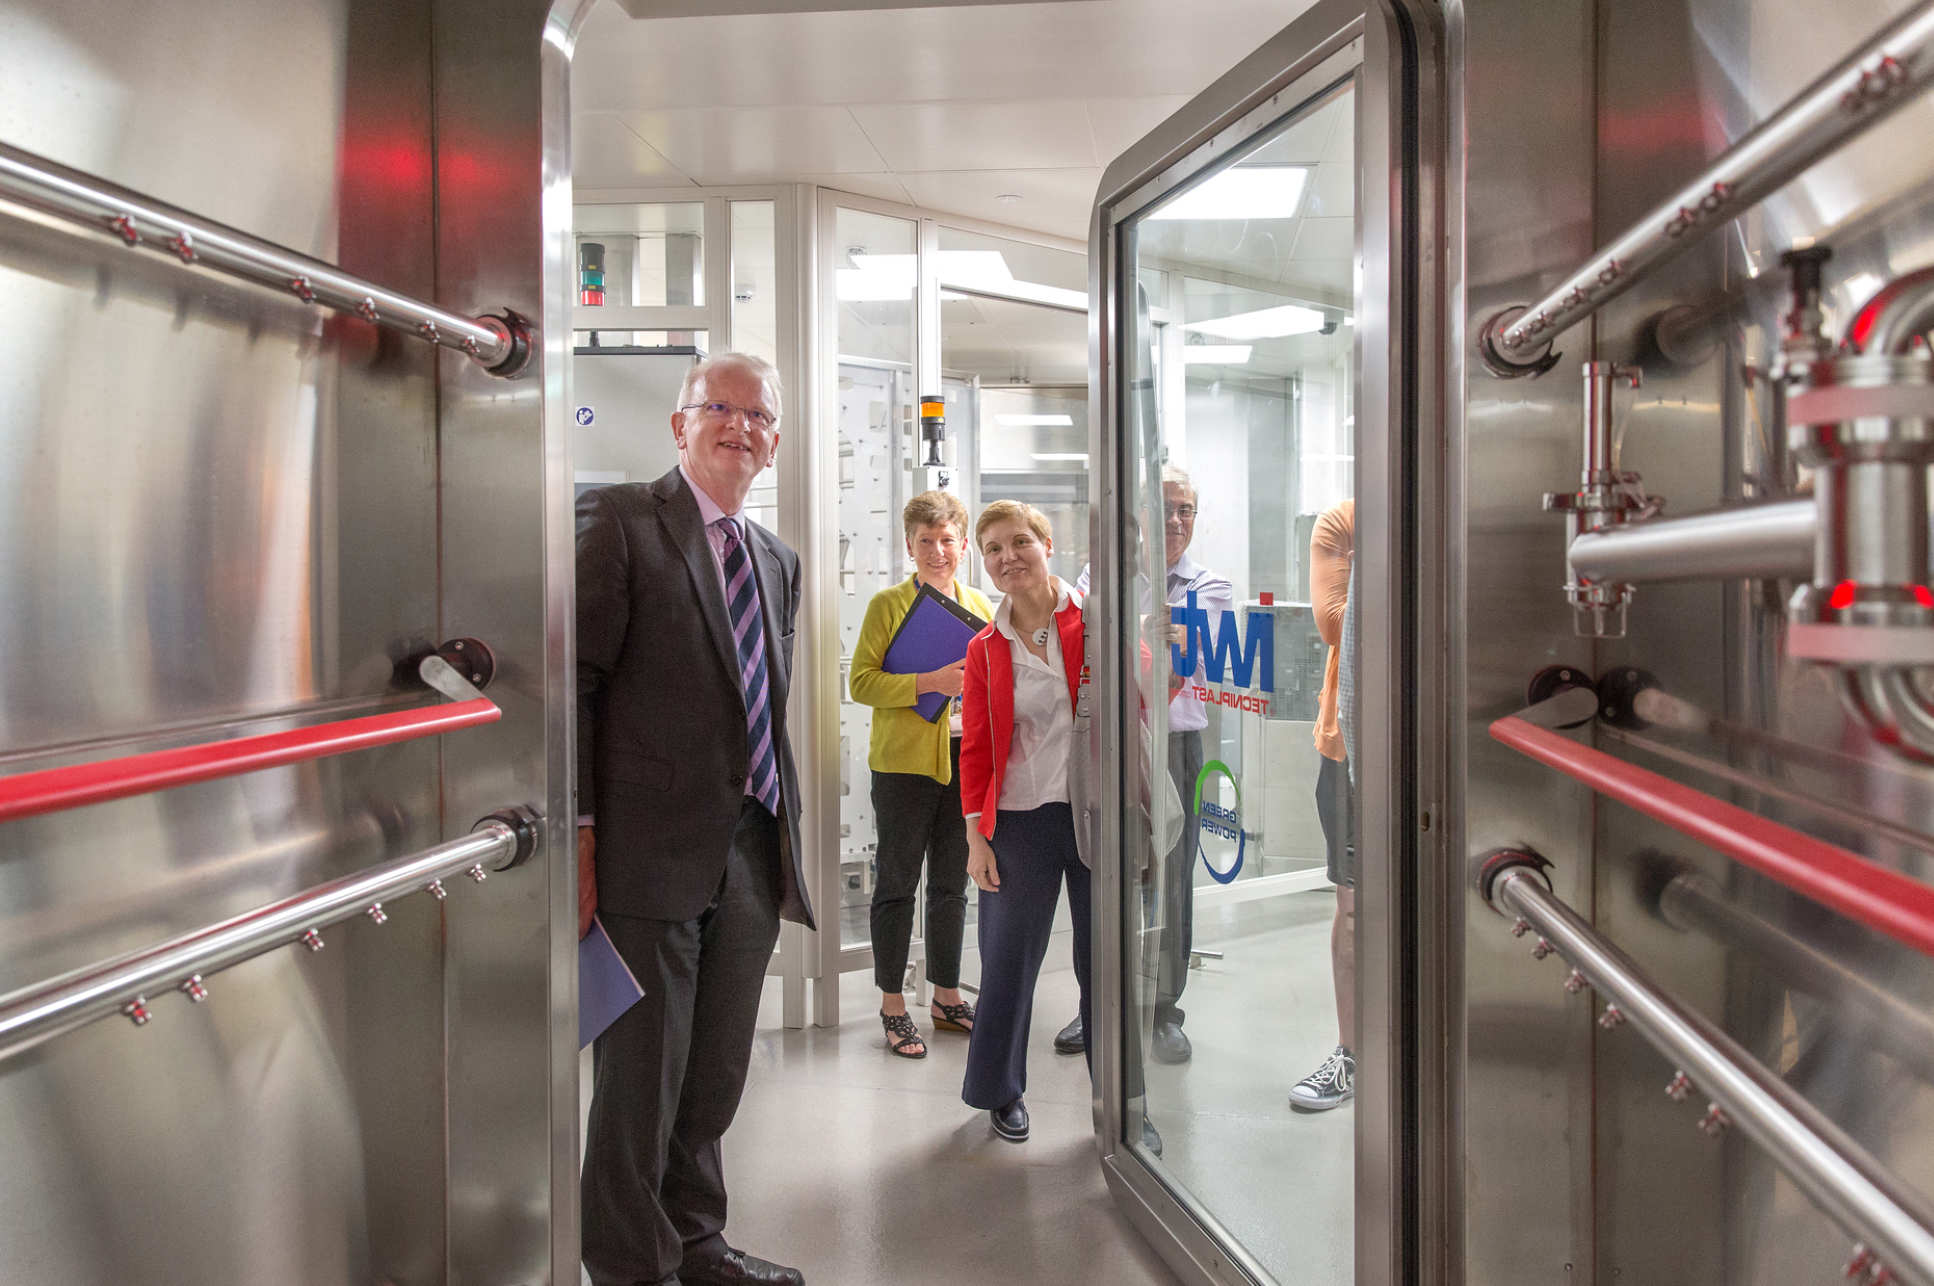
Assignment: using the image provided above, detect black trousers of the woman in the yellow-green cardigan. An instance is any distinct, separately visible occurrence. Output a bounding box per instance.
[870,737,967,992]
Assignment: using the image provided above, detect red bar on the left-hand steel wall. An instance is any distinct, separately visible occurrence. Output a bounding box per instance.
[0,696,503,822]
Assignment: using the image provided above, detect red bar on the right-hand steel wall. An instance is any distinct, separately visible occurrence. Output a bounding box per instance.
[1491,716,1934,955]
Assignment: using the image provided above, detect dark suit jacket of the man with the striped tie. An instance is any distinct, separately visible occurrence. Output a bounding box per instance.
[578,470,812,928]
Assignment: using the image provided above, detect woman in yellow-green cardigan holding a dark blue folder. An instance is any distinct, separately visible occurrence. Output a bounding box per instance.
[847,491,994,1058]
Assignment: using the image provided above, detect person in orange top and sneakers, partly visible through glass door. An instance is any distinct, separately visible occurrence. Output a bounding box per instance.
[1290,501,1356,1112]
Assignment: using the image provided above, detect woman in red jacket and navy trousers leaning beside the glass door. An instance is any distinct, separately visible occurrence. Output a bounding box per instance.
[961,501,1089,1143]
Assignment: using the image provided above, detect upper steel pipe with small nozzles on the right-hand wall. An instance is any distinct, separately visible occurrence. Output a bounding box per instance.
[1480,0,1934,375]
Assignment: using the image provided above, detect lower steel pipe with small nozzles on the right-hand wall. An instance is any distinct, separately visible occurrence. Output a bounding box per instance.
[1480,851,1934,1286]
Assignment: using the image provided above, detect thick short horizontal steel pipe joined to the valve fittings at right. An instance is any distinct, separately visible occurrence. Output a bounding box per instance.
[1568,501,1820,584]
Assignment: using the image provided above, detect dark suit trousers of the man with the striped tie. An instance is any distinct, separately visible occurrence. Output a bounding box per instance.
[580,799,779,1286]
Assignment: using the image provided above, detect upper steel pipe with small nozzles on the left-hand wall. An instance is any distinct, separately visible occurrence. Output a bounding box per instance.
[0,143,532,375]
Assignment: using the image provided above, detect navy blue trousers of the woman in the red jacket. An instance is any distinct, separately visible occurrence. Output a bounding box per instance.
[961,804,1093,1108]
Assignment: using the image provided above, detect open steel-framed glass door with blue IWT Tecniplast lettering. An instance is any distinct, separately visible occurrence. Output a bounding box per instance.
[1089,4,1439,1282]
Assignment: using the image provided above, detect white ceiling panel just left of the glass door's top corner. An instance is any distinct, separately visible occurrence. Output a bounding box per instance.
[853,99,1097,170]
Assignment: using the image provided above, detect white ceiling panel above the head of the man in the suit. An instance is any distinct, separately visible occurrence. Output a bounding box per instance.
[623,106,892,184]
